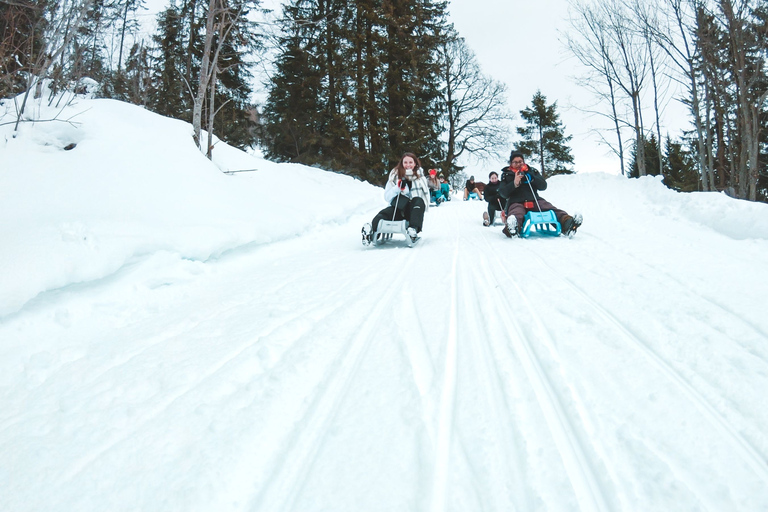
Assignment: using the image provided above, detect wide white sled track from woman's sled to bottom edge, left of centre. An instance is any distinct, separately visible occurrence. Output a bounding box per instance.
[248,252,418,512]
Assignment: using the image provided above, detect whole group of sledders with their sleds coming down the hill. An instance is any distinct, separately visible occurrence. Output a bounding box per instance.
[362,151,582,246]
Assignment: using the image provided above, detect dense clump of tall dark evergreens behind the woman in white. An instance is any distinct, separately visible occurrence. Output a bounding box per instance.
[264,0,446,181]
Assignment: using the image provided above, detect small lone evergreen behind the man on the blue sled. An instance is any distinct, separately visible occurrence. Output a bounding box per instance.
[517,91,573,178]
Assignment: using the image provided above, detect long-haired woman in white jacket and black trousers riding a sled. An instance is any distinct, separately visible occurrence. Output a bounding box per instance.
[366,153,429,243]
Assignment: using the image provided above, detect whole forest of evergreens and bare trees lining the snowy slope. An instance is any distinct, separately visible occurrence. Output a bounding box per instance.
[0,0,768,201]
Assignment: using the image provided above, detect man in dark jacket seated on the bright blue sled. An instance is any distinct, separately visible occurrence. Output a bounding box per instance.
[499,151,581,238]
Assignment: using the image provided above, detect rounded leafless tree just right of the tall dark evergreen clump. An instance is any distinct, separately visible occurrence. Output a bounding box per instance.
[439,36,512,174]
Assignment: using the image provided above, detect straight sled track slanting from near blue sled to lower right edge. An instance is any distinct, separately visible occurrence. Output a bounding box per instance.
[520,244,768,482]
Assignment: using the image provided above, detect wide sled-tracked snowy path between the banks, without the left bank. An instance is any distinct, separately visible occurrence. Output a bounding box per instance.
[0,201,768,512]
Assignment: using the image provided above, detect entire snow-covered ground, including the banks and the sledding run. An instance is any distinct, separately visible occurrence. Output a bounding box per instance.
[0,93,768,512]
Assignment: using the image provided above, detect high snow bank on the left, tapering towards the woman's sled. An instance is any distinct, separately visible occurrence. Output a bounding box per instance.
[0,93,381,315]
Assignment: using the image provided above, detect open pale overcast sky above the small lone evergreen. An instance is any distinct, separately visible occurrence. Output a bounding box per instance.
[449,0,619,174]
